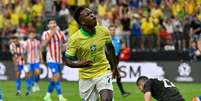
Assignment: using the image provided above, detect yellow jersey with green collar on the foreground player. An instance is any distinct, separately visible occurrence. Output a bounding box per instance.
[65,26,112,80]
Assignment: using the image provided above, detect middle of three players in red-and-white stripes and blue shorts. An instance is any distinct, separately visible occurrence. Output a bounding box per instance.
[24,32,41,92]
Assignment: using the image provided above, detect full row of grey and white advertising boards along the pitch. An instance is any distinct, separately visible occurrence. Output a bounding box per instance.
[0,61,201,82]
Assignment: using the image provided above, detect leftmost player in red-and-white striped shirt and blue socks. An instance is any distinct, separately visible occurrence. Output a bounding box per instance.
[10,35,31,96]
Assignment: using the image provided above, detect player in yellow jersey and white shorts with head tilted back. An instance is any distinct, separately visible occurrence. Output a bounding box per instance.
[64,7,118,101]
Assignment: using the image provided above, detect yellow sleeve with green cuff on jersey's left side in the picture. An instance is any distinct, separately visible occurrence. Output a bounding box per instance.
[65,38,77,58]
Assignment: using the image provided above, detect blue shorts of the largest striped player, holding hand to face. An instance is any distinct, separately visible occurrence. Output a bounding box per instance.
[47,63,61,75]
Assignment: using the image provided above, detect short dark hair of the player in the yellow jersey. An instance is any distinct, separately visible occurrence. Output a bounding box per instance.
[73,7,85,24]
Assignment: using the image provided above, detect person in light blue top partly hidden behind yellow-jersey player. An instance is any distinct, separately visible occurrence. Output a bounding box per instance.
[109,25,130,96]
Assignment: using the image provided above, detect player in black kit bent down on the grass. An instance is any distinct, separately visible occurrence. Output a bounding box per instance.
[137,76,185,101]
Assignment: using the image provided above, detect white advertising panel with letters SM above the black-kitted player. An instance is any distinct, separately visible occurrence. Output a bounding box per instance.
[118,62,165,82]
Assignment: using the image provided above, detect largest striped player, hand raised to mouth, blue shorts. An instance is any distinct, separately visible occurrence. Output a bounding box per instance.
[41,18,66,101]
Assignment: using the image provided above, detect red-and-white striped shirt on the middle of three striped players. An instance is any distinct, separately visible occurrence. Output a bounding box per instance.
[24,39,40,64]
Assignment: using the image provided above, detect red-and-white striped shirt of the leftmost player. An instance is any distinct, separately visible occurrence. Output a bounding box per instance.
[10,42,25,65]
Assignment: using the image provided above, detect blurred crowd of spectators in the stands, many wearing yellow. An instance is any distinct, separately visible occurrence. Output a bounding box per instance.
[0,0,201,58]
